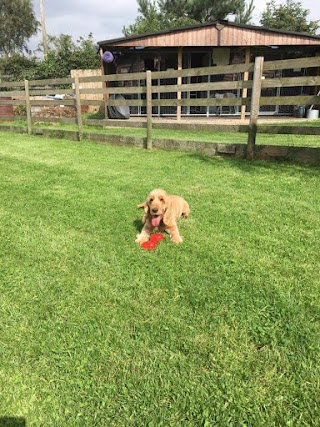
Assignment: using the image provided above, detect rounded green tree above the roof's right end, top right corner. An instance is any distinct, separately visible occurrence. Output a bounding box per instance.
[260,0,320,34]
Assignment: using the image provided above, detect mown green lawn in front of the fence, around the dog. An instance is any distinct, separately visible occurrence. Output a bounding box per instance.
[0,132,320,427]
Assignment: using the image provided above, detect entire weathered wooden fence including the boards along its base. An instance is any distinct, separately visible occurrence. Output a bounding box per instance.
[0,57,320,163]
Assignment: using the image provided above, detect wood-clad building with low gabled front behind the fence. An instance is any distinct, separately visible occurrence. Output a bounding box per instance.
[98,20,320,116]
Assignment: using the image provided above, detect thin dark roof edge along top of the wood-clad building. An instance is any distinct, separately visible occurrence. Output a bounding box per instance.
[98,20,320,46]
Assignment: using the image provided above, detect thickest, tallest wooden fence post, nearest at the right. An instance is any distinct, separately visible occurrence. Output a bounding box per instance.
[247,56,264,160]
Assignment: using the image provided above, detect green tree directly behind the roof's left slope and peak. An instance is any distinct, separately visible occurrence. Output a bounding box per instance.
[123,0,254,36]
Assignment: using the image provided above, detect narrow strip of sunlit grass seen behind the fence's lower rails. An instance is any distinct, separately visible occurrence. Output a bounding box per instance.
[0,120,320,147]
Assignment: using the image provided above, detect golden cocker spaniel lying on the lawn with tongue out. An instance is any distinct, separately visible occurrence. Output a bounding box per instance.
[136,189,190,244]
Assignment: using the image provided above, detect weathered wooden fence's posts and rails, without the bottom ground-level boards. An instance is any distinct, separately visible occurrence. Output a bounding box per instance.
[0,57,320,159]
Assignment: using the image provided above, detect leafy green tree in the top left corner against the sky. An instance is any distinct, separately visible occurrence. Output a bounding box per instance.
[0,0,39,56]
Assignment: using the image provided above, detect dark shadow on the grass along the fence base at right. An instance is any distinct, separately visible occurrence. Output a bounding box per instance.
[189,153,320,177]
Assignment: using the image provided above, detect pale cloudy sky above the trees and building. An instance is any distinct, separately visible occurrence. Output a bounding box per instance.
[30,0,320,49]
